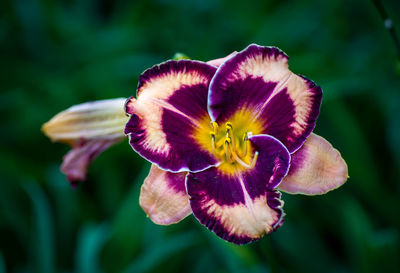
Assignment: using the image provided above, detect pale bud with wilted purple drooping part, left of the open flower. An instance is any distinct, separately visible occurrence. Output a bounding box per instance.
[42,98,128,186]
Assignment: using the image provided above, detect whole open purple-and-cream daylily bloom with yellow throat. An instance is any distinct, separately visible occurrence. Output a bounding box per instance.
[125,44,348,244]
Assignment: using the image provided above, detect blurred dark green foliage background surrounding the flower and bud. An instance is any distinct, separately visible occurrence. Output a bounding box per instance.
[0,0,400,273]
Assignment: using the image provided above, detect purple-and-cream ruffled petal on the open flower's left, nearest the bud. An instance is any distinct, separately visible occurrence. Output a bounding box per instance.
[125,60,216,172]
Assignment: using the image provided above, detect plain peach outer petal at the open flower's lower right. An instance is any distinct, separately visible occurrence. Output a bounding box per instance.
[279,134,348,195]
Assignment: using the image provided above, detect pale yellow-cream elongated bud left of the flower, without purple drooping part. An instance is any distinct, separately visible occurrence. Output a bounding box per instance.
[42,98,128,145]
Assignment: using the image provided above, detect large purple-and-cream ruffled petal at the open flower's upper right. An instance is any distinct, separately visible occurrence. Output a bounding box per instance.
[208,44,322,153]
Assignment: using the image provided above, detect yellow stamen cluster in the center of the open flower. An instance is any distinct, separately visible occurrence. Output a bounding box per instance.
[210,122,258,169]
